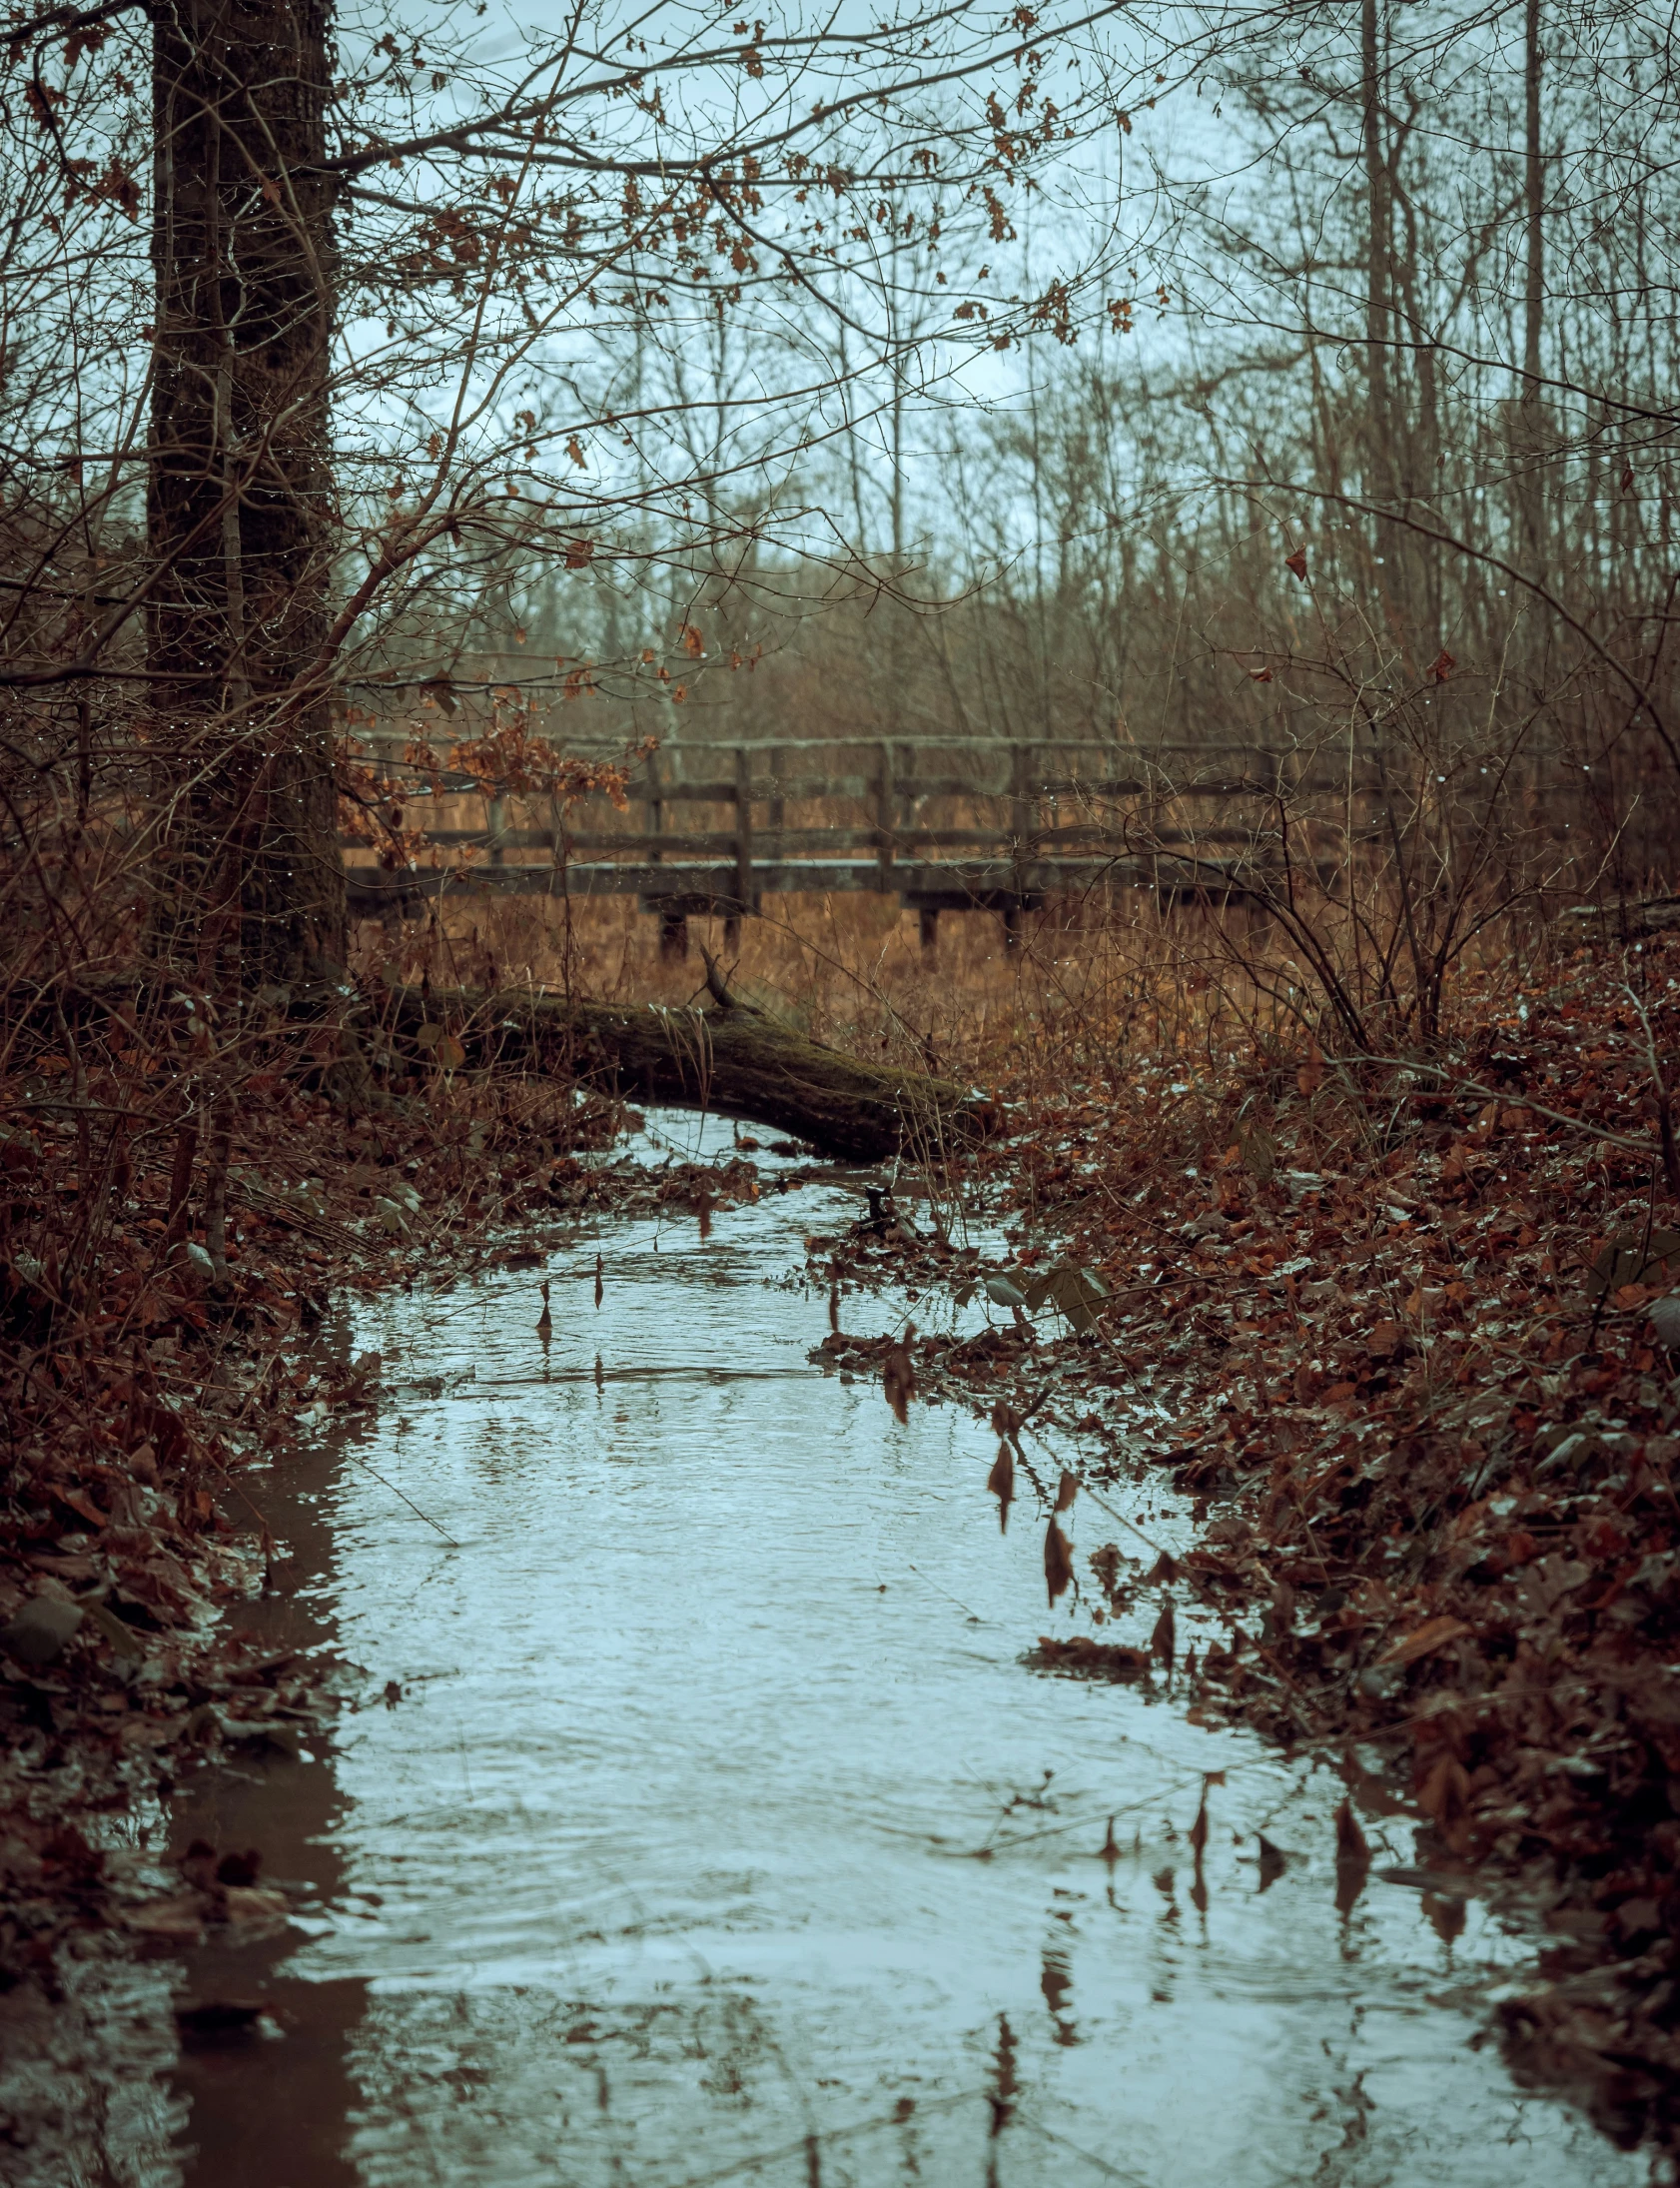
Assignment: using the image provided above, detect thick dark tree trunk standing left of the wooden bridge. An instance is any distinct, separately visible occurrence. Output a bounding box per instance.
[147,0,346,987]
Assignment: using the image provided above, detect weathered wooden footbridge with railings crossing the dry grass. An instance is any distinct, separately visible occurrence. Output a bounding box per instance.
[346,737,1349,954]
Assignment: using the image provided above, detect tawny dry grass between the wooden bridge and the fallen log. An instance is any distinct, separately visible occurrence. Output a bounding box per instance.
[355,893,1551,1112]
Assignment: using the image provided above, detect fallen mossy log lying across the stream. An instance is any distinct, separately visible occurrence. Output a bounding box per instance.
[392,980,995,1162]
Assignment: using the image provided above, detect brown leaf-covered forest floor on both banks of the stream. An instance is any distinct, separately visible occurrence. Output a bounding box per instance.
[0,918,1680,2140]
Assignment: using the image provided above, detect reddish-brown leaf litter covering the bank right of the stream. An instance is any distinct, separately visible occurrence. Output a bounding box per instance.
[812,939,1680,2142]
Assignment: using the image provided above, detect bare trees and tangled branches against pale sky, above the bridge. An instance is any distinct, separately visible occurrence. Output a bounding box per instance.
[0,0,1680,1035]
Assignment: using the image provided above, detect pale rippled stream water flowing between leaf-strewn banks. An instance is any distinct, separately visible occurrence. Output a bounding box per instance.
[22,1118,1645,2188]
